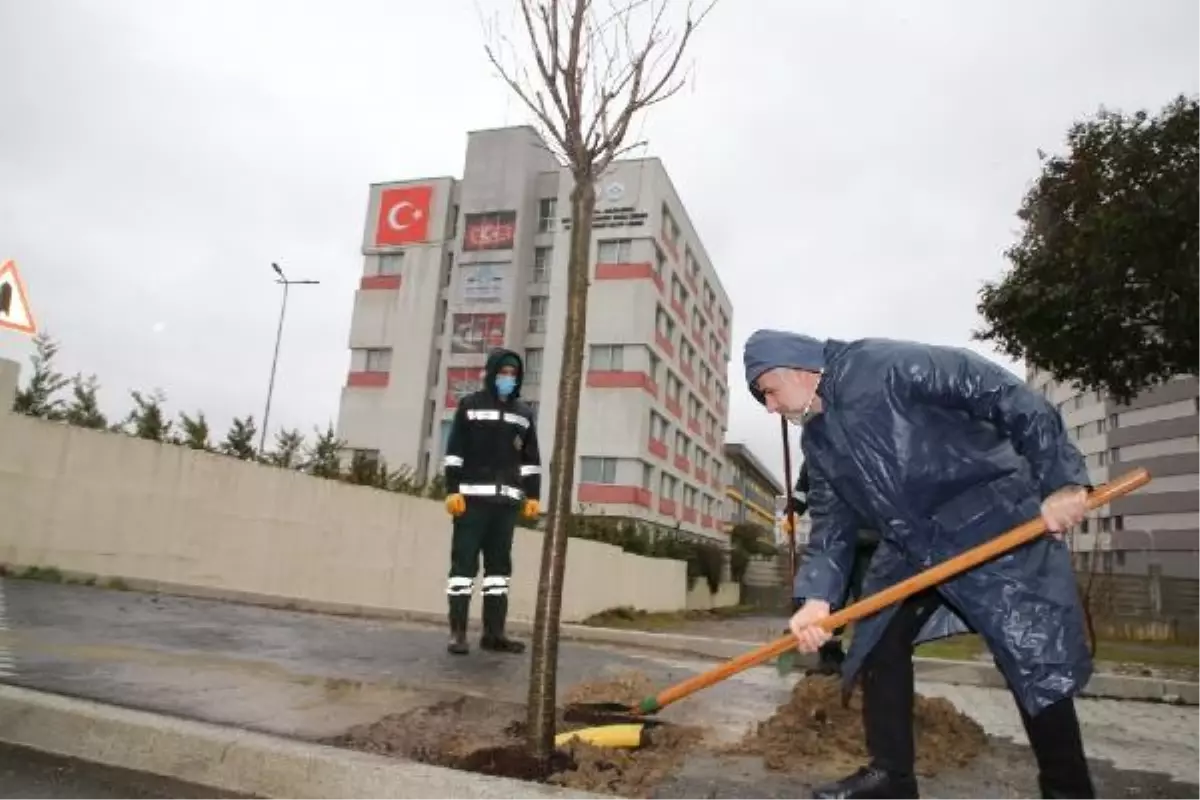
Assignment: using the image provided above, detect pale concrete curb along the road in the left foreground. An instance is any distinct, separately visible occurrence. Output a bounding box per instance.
[0,686,601,800]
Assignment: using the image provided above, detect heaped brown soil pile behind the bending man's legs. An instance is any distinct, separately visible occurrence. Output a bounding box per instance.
[731,676,988,776]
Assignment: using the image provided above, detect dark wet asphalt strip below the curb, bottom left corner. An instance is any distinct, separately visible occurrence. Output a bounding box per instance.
[0,745,260,800]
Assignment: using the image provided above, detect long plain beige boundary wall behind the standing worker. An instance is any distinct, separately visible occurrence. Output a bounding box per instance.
[0,413,698,621]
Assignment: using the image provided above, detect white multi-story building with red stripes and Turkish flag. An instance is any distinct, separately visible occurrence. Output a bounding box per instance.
[337,127,733,535]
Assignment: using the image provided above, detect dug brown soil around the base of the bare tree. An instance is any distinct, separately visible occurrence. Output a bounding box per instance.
[324,673,701,798]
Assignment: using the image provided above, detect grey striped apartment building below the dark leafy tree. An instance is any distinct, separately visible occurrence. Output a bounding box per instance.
[1027,369,1200,577]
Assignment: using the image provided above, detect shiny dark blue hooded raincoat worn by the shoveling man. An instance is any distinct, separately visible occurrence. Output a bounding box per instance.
[744,331,1092,715]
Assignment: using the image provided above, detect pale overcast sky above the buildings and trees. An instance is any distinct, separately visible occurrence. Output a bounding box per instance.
[0,0,1200,482]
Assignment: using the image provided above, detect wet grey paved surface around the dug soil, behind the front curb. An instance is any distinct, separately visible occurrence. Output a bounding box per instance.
[0,579,1200,800]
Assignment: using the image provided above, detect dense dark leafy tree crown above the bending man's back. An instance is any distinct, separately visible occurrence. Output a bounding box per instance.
[974,96,1200,401]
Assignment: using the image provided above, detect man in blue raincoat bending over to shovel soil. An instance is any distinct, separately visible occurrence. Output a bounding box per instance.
[743,330,1096,800]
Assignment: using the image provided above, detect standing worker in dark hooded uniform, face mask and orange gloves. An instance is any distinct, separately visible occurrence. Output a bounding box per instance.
[445,349,541,655]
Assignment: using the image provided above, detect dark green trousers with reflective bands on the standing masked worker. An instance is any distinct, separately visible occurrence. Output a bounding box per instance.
[448,497,520,637]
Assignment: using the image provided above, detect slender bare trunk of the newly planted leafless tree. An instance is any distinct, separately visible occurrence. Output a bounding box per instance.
[528,175,596,764]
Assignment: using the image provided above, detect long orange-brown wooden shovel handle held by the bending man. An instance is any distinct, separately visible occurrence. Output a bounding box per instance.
[640,469,1150,712]
